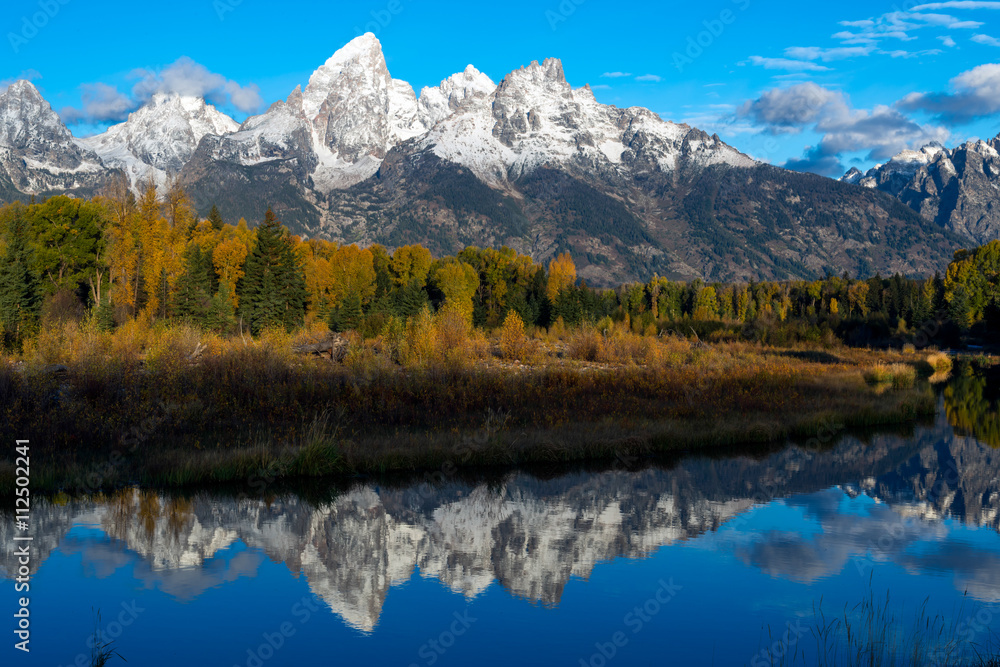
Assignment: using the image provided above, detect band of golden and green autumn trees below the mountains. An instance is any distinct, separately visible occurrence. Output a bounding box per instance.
[0,180,1000,349]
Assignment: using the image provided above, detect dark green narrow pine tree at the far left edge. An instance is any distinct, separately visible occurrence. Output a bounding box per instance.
[0,207,42,348]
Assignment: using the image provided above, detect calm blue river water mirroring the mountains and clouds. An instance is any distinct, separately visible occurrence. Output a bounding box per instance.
[0,378,1000,667]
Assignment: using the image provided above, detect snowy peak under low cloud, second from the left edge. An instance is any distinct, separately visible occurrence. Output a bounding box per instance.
[77,93,239,187]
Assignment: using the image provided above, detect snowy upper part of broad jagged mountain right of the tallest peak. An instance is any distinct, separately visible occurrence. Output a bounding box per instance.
[417,59,756,186]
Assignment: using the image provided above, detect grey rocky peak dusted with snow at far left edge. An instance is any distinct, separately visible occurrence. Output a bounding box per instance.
[0,81,105,194]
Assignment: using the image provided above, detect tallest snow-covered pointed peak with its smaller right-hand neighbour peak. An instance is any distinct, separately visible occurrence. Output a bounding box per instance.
[185,34,496,195]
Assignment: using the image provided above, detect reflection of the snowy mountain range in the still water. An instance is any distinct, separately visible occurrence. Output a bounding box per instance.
[0,424,1000,632]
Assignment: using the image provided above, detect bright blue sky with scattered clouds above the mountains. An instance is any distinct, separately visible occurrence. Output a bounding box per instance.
[0,0,1000,175]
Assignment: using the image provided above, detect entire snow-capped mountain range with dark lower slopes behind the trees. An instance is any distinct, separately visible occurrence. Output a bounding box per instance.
[0,34,984,285]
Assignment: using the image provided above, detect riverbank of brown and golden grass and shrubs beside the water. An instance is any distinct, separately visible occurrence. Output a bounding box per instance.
[0,326,935,492]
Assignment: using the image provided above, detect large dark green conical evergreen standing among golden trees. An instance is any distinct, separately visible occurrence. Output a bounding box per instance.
[238,209,308,335]
